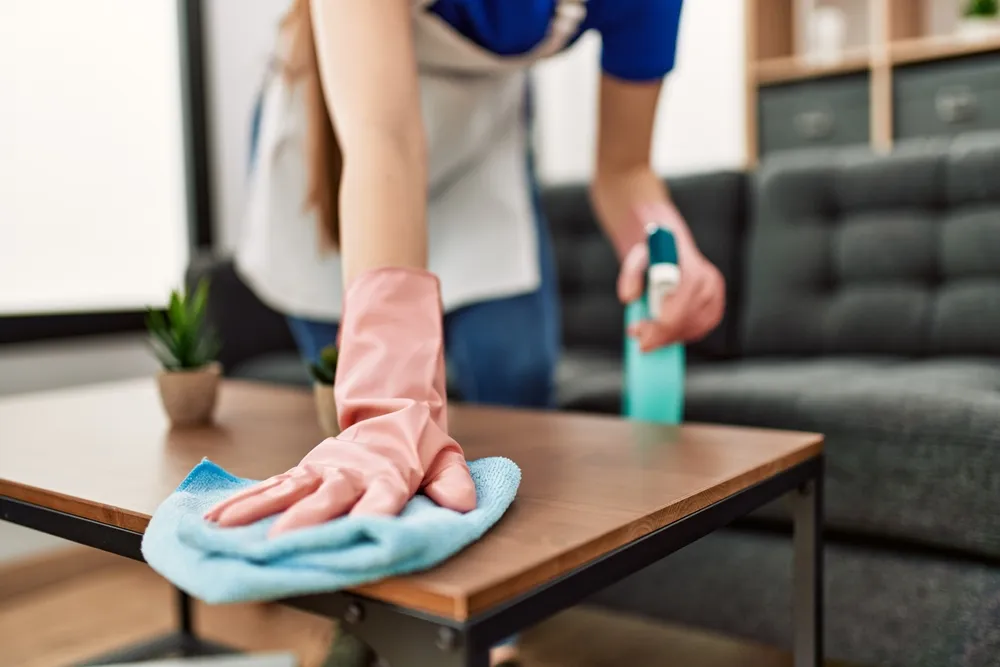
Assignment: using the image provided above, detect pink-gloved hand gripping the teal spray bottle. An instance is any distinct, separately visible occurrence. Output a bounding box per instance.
[618,204,726,352]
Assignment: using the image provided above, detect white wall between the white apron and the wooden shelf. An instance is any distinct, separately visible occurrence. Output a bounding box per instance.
[536,0,746,182]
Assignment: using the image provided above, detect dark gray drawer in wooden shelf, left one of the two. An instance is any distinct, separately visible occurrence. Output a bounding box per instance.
[757,73,870,155]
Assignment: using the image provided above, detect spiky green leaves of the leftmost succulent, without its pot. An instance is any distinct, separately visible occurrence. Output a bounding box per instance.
[146,280,220,371]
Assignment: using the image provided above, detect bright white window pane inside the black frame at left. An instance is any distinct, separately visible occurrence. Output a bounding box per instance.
[0,0,188,314]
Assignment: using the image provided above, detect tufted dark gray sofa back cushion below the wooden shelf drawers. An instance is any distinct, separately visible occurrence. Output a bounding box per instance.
[743,133,1000,355]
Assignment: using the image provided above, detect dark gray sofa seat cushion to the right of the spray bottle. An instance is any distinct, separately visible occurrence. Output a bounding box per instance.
[686,358,1000,557]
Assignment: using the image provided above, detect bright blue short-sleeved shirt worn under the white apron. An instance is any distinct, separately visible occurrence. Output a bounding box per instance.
[431,0,683,81]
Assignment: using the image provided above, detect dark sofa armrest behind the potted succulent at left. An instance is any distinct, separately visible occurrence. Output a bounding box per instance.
[185,253,296,375]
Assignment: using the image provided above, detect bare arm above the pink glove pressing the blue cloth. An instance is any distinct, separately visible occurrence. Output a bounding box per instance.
[310,0,427,284]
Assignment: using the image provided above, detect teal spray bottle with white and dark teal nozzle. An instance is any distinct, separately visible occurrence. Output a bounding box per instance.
[622,224,685,424]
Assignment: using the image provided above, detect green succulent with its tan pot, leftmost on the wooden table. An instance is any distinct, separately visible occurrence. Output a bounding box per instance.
[146,280,221,426]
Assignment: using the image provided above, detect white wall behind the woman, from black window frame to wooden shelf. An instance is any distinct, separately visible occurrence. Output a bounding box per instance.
[207,0,746,249]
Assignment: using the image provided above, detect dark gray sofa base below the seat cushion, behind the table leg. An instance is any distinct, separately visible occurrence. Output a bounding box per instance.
[591,530,1000,667]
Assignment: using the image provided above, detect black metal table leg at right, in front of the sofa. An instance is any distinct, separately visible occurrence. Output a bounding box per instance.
[792,466,823,667]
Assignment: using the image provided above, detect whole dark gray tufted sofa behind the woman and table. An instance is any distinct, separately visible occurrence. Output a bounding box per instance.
[189,134,1000,667]
